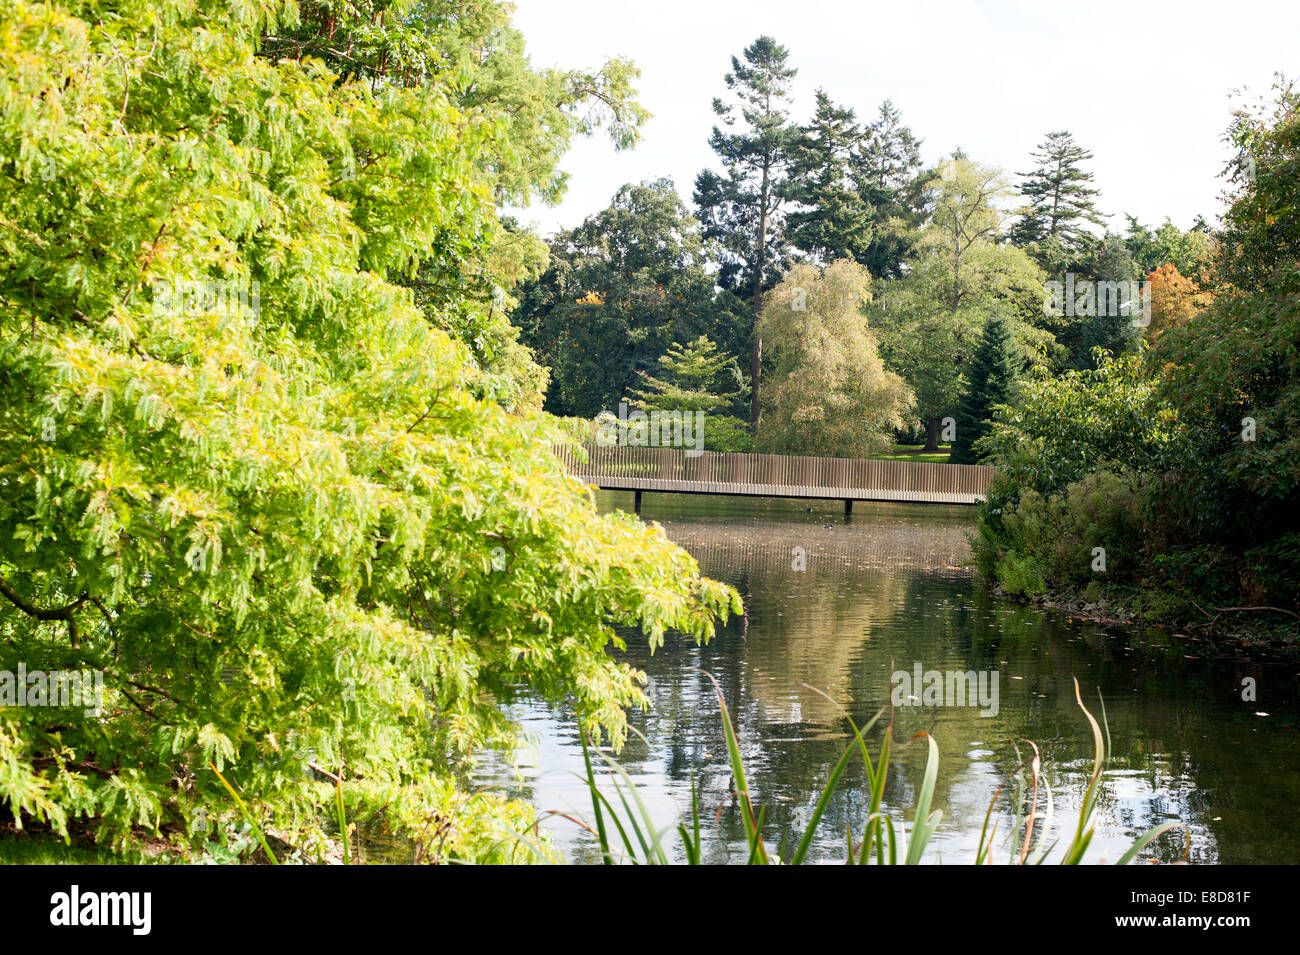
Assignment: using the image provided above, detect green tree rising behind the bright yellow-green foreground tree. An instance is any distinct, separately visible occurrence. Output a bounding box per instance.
[256,0,649,418]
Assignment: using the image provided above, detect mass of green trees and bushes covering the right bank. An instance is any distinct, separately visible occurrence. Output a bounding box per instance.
[974,81,1300,628]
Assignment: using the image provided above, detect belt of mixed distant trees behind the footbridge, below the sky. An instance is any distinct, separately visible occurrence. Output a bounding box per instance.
[512,36,1212,461]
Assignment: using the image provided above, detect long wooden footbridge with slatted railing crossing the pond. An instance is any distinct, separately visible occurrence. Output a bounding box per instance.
[556,446,993,515]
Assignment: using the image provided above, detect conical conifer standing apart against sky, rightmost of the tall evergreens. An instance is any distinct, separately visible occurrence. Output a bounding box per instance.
[1011,130,1105,257]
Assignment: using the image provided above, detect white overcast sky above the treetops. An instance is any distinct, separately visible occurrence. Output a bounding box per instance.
[515,0,1300,234]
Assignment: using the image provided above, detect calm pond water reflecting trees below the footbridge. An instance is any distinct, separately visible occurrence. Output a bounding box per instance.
[473,492,1300,863]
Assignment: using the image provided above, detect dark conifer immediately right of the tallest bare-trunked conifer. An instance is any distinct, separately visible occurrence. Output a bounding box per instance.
[787,90,872,264]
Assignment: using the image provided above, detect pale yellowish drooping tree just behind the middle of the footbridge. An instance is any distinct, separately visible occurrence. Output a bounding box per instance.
[758,259,913,457]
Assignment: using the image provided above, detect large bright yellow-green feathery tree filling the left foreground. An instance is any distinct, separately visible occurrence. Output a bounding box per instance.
[0,0,738,859]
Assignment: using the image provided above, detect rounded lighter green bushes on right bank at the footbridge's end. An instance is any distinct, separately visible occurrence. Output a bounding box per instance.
[972,343,1180,605]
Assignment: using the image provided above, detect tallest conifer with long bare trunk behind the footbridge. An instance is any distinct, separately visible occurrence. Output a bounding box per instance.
[694,36,797,427]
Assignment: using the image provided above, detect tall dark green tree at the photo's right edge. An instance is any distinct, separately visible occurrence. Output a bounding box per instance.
[1156,79,1300,607]
